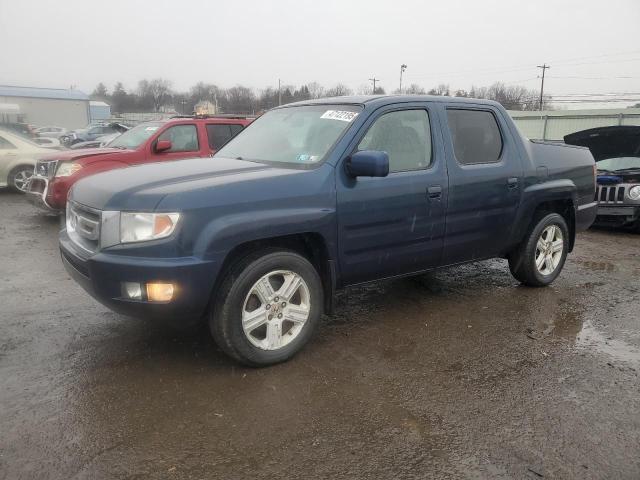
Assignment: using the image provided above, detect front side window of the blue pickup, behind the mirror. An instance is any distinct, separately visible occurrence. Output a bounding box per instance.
[358,110,431,172]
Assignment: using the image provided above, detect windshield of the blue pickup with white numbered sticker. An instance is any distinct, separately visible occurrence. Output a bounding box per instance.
[216,105,361,165]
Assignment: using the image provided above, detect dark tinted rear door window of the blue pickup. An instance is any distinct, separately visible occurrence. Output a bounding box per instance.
[447,109,502,165]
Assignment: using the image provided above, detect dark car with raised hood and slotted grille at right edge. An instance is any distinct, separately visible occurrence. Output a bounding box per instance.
[564,125,640,231]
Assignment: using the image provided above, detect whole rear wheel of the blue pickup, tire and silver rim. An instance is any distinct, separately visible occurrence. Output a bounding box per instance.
[509,213,569,287]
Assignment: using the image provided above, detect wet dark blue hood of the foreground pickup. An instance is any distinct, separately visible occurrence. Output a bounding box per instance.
[70,157,300,211]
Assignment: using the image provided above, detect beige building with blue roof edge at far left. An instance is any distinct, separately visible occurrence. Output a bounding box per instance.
[0,85,90,129]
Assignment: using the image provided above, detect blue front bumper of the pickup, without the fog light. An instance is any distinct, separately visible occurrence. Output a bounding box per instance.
[60,230,219,323]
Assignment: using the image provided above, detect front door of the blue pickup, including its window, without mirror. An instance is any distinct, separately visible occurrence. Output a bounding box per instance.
[337,104,447,285]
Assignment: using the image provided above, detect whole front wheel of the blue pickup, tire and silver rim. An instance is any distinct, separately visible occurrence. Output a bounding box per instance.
[209,250,324,367]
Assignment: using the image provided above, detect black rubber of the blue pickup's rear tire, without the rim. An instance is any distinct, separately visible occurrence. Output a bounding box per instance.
[508,213,569,287]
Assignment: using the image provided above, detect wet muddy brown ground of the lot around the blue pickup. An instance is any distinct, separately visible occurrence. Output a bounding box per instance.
[0,192,640,479]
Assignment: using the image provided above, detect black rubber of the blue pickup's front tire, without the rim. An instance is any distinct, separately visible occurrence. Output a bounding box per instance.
[209,249,324,367]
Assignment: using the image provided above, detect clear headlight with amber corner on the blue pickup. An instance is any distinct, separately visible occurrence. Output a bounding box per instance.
[120,212,180,243]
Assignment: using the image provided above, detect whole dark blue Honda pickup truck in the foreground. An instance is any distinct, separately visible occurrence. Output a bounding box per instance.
[60,96,596,366]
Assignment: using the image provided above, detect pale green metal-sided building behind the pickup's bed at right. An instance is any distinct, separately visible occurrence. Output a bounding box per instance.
[509,108,640,141]
